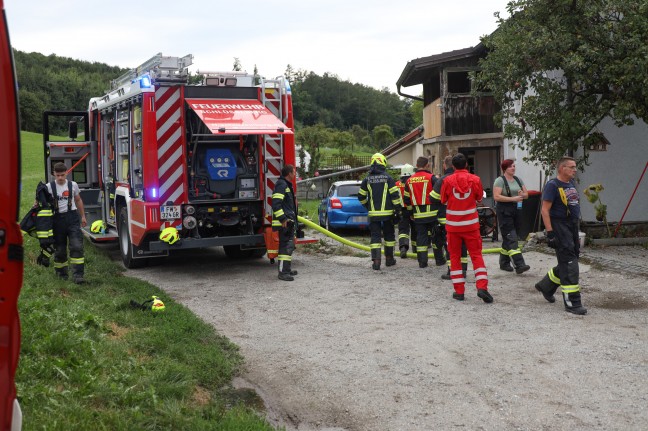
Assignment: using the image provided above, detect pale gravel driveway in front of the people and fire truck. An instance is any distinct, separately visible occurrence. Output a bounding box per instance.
[128,244,648,431]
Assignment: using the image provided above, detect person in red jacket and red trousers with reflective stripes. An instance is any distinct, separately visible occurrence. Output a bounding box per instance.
[441,153,493,303]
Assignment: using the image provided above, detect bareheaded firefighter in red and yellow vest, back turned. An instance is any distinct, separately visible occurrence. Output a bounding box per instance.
[405,157,446,268]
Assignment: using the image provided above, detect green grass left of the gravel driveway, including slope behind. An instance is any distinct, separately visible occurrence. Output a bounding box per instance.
[16,133,273,431]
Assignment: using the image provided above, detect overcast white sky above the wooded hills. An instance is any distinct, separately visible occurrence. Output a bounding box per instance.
[5,0,508,93]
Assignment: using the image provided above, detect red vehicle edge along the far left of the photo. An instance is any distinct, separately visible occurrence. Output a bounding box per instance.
[0,0,23,431]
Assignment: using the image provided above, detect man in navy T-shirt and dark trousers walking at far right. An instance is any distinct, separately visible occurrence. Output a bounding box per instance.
[535,157,587,315]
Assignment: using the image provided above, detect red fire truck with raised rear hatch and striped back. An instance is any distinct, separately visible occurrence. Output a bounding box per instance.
[43,54,310,268]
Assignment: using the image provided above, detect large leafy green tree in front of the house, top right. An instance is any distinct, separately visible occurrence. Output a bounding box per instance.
[475,0,648,170]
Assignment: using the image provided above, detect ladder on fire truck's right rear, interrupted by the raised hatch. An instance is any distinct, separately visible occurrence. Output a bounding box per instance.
[260,77,287,224]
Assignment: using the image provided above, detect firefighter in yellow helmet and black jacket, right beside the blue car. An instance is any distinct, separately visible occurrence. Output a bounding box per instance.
[358,153,401,270]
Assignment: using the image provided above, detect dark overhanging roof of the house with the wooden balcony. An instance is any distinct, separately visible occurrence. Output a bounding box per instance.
[396,43,486,88]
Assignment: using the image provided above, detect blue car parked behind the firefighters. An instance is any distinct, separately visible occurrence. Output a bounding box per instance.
[318,181,369,231]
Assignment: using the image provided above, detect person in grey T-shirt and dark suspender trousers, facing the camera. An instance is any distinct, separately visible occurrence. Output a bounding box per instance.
[493,159,531,274]
